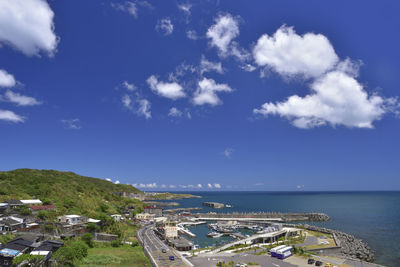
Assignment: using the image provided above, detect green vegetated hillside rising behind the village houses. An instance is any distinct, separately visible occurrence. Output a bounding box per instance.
[0,169,143,220]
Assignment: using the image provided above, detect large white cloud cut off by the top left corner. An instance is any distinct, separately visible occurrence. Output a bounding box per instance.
[0,0,58,56]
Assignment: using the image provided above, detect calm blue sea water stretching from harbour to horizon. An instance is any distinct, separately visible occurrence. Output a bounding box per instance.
[164,192,400,266]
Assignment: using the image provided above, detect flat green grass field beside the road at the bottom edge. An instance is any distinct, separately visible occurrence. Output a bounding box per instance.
[78,245,151,267]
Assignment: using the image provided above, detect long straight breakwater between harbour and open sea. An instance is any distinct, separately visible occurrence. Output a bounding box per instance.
[193,212,330,222]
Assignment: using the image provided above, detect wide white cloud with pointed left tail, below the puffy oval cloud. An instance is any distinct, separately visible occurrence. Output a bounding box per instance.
[254,68,397,128]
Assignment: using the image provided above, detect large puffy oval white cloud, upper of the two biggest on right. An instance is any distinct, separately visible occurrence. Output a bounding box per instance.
[253,25,339,78]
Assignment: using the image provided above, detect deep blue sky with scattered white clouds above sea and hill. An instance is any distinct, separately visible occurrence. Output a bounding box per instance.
[0,0,400,191]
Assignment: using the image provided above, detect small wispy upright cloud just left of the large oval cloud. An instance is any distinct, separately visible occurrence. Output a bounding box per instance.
[206,14,240,56]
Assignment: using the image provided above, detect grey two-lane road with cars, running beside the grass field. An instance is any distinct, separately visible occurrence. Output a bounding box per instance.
[138,226,189,267]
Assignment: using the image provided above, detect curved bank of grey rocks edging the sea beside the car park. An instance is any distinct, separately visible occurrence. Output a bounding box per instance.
[302,224,374,262]
